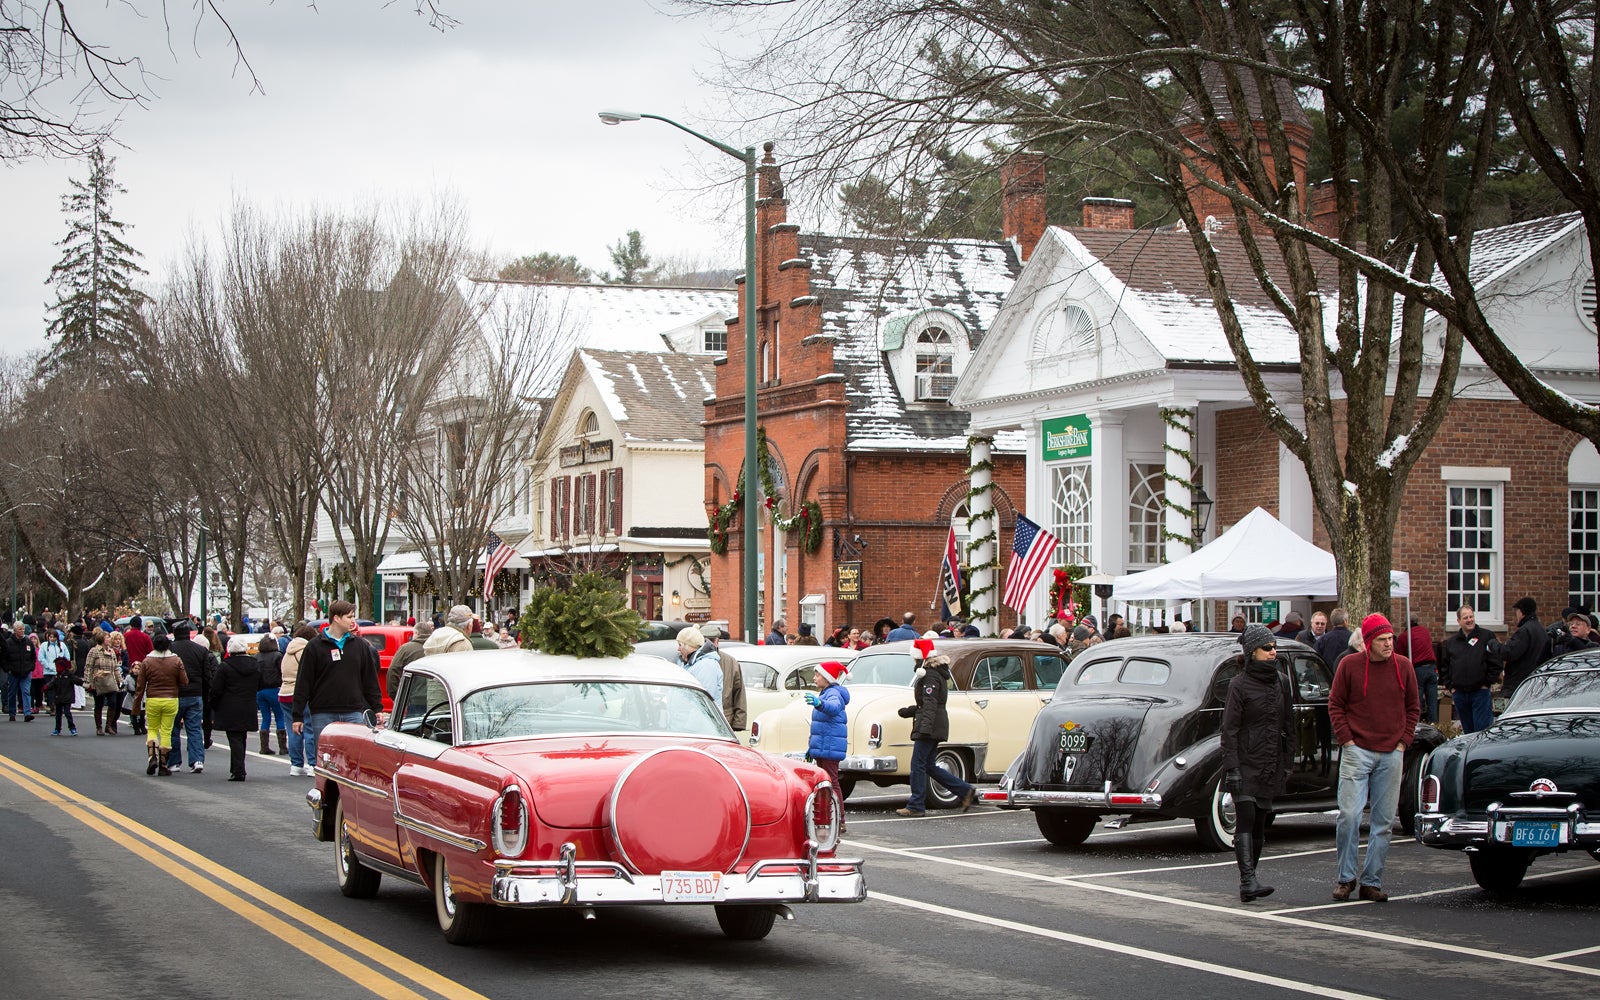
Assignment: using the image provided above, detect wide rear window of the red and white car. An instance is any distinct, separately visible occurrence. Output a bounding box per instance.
[456,680,733,742]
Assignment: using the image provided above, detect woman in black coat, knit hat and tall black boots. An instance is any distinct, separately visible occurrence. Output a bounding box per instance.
[1222,624,1294,902]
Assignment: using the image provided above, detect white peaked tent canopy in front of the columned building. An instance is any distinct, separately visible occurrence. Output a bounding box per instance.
[1112,507,1411,620]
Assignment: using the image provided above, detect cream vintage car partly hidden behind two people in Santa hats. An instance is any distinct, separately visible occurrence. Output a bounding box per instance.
[746,638,1067,808]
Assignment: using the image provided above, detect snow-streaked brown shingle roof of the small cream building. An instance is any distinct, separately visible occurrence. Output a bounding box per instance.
[578,349,717,443]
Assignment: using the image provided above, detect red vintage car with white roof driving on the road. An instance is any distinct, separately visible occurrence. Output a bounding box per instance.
[307,650,866,944]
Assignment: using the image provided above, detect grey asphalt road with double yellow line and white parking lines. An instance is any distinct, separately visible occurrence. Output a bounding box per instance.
[0,718,1600,1000]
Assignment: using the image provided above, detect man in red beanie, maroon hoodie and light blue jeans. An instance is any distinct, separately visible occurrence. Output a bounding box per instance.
[1328,614,1421,902]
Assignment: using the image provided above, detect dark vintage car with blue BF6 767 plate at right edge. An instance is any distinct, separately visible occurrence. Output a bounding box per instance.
[1416,650,1600,893]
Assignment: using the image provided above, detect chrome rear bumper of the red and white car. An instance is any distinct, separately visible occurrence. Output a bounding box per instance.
[493,843,867,907]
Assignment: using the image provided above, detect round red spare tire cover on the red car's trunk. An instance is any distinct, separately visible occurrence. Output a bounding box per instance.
[608,747,750,875]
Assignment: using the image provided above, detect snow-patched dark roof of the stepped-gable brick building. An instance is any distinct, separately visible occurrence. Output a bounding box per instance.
[800,234,1022,450]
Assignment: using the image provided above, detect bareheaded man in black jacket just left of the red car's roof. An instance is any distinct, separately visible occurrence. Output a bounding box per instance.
[290,600,384,766]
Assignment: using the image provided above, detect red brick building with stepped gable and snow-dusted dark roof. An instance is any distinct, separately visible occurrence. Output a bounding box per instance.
[706,147,1042,634]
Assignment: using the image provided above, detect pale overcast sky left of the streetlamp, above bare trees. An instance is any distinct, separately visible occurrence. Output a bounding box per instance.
[0,0,758,354]
